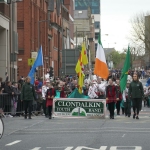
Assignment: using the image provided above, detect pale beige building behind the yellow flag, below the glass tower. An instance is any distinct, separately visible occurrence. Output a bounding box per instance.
[74,7,95,68]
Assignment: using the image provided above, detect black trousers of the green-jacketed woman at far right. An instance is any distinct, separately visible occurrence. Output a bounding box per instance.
[132,98,142,115]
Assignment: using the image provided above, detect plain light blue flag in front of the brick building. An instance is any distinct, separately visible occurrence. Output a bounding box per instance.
[28,46,43,84]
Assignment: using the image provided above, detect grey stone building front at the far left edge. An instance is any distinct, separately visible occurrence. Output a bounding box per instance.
[0,0,18,81]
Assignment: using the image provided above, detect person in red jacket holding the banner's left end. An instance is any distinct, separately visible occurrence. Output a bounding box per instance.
[46,83,56,119]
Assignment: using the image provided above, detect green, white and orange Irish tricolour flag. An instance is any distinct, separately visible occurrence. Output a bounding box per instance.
[94,35,109,79]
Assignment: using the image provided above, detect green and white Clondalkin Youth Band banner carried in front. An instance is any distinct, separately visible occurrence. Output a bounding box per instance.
[53,98,106,118]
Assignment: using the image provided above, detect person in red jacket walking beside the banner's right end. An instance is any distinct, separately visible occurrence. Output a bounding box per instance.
[106,78,119,119]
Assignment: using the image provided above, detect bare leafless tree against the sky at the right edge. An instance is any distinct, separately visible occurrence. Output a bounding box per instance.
[129,12,150,55]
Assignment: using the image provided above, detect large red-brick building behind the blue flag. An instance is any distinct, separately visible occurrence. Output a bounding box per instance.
[17,0,62,76]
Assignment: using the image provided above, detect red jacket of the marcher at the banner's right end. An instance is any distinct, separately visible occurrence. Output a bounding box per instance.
[106,85,119,103]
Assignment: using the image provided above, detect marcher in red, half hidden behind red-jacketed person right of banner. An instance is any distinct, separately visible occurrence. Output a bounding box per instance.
[116,79,122,115]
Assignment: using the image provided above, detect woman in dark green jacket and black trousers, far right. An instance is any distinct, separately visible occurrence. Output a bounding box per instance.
[128,73,144,119]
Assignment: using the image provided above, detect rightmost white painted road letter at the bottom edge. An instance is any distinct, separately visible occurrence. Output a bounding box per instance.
[110,146,142,150]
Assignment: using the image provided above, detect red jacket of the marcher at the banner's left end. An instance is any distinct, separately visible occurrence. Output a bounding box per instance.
[46,88,56,107]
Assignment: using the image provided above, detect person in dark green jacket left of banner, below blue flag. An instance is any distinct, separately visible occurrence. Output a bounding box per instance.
[21,77,37,119]
